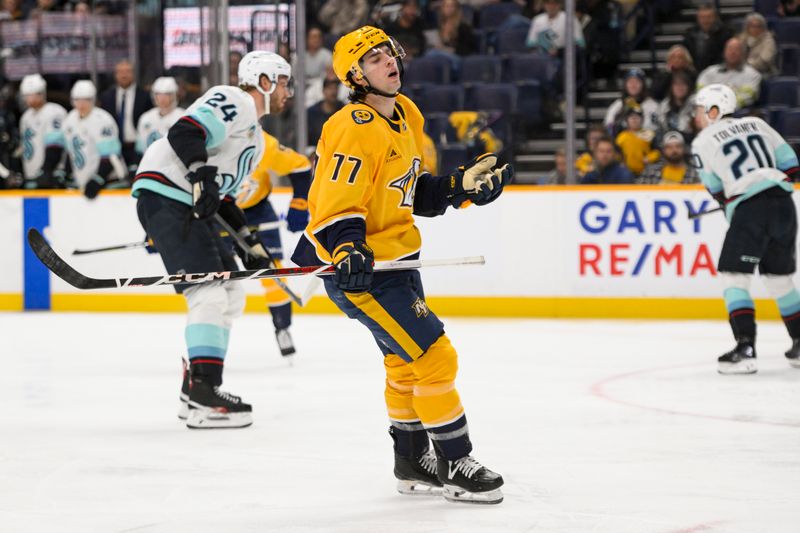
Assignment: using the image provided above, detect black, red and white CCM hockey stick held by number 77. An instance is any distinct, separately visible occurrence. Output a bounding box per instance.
[28,228,486,290]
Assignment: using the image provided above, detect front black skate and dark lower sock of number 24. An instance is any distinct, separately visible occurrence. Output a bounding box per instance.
[186,363,253,429]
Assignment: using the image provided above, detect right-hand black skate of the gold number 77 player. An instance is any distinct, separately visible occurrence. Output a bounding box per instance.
[437,455,503,504]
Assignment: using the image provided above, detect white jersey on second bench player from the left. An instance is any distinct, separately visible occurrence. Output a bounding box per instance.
[64,107,122,187]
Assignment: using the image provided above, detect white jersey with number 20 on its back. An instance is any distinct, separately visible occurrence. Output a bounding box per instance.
[692,117,797,217]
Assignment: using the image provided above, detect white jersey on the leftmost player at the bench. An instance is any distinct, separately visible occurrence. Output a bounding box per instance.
[19,102,67,179]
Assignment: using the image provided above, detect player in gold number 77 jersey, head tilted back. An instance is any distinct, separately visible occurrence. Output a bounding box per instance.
[292,26,513,503]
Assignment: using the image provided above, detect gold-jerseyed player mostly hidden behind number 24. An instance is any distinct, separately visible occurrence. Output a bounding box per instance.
[236,97,311,356]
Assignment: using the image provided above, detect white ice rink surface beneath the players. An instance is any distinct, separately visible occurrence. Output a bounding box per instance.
[0,313,800,533]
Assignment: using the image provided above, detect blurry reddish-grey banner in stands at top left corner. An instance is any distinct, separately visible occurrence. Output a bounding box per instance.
[0,13,128,80]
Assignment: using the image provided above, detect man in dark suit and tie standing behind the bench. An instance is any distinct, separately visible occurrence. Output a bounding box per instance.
[100,59,153,166]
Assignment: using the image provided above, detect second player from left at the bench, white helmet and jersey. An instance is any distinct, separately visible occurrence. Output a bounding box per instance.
[64,80,127,199]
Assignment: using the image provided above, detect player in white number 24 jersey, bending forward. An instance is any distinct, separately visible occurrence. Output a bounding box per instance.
[133,52,291,428]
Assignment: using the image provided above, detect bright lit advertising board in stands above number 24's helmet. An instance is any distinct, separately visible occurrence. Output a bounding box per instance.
[164,4,295,68]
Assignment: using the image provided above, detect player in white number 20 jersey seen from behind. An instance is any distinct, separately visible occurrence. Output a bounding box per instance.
[692,84,800,374]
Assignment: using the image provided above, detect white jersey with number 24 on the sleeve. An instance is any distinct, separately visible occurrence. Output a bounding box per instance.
[132,85,264,205]
